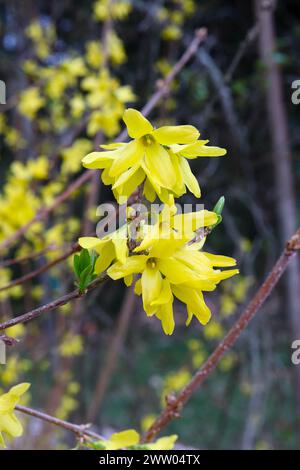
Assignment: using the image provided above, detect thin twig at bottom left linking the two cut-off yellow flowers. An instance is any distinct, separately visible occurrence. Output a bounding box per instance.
[15,405,103,440]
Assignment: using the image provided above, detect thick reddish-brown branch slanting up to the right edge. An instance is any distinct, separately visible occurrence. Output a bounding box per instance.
[143,229,300,442]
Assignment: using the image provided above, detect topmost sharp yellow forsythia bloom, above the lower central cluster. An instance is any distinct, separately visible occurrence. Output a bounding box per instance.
[82,108,226,203]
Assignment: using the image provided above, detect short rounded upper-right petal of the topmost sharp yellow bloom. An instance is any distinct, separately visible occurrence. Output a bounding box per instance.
[152,125,200,145]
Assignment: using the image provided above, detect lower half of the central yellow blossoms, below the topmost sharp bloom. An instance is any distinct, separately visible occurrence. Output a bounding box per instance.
[79,206,238,335]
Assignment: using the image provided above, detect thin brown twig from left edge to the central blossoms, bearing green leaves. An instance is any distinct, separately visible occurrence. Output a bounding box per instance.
[0,274,108,331]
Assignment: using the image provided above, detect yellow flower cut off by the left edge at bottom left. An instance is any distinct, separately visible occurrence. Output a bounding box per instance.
[0,383,30,447]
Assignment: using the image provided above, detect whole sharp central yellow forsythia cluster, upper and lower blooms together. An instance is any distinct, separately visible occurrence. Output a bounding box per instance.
[79,109,238,335]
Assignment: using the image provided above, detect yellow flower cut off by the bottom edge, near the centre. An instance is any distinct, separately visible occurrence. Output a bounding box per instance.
[92,429,177,450]
